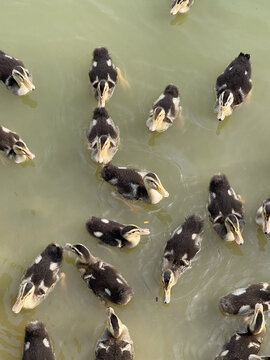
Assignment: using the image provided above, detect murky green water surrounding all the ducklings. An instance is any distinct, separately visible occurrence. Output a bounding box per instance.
[0,0,270,360]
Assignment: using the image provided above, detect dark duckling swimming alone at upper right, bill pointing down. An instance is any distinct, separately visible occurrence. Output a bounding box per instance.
[215,52,252,120]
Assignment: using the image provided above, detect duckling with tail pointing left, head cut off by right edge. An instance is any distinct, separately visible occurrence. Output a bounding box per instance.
[219,283,270,315]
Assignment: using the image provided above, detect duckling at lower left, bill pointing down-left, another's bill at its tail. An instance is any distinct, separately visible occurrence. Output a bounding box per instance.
[12,243,64,314]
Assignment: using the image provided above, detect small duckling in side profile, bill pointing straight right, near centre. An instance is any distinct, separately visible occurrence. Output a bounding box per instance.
[86,216,150,248]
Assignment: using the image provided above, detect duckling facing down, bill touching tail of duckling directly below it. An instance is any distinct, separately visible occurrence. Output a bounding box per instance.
[89,47,118,107]
